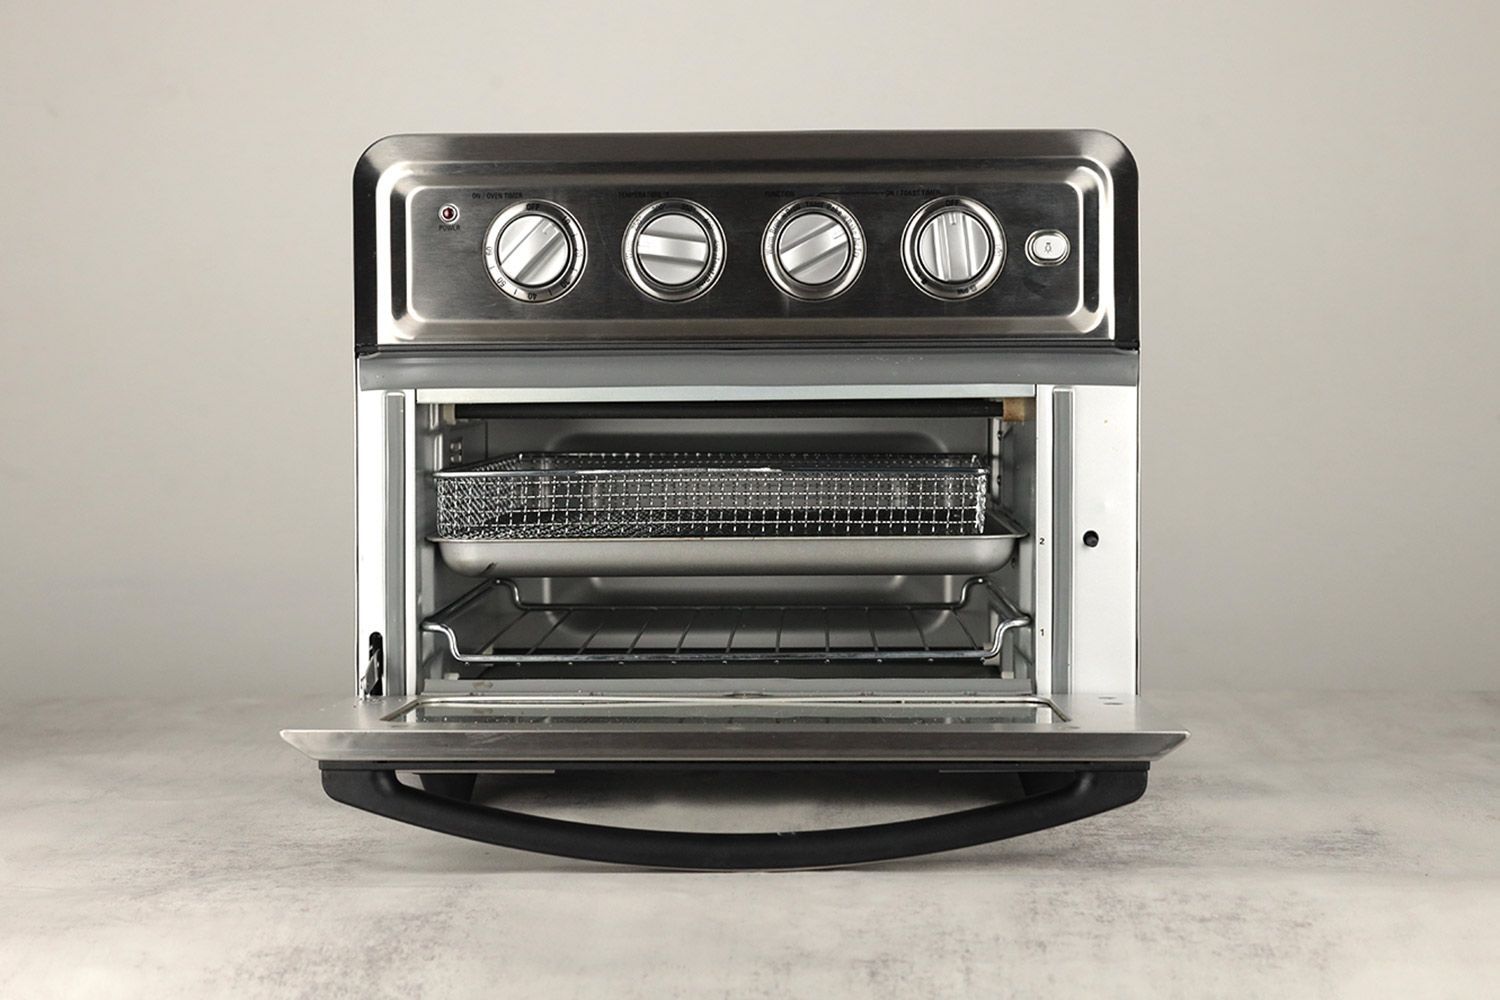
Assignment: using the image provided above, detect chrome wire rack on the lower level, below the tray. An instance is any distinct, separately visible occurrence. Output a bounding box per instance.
[422,577,1031,664]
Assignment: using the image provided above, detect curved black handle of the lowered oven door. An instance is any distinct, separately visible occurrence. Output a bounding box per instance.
[323,765,1146,871]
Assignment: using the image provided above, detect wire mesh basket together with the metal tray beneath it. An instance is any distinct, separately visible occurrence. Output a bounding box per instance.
[435,453,1025,576]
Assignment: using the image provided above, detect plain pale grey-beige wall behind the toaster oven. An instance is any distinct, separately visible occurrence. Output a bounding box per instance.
[0,0,1500,697]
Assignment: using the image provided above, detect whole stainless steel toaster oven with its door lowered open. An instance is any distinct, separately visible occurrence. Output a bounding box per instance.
[284,130,1187,868]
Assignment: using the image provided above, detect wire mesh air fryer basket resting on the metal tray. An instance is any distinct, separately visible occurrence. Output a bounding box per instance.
[435,453,987,540]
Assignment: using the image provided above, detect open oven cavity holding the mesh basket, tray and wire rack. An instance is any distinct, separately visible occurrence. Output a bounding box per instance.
[405,399,1037,694]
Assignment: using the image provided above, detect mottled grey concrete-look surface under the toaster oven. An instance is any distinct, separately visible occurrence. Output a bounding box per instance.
[0,694,1500,1000]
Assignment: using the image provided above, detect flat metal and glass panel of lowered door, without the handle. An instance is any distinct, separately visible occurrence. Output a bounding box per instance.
[282,692,1188,765]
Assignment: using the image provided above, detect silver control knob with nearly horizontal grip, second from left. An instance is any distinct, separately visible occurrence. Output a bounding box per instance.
[620,199,725,301]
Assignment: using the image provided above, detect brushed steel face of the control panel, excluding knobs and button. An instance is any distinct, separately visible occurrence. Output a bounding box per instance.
[356,132,1136,349]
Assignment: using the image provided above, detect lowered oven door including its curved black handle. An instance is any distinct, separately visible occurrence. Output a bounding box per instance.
[282,689,1187,870]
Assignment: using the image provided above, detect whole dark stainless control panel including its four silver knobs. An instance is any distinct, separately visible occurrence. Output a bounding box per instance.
[356,132,1136,349]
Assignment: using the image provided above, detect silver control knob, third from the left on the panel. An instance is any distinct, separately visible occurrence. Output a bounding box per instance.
[761,198,864,300]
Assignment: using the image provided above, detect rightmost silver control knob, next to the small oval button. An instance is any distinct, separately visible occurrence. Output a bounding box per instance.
[902,196,1005,300]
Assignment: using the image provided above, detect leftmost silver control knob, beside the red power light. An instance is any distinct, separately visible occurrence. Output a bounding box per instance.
[485,201,588,303]
